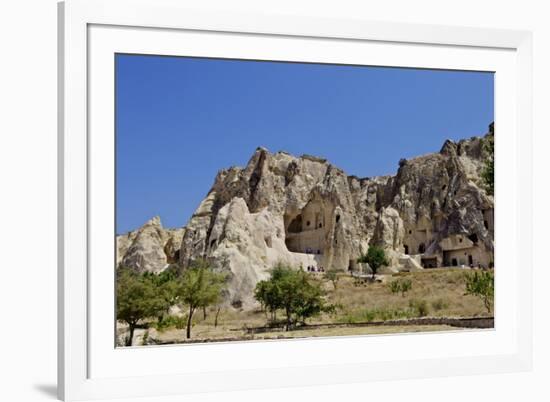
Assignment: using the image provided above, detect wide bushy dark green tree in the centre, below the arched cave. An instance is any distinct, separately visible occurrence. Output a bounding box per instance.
[254,264,334,331]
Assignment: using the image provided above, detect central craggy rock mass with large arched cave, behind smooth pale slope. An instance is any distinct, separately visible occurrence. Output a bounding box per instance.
[180,148,368,276]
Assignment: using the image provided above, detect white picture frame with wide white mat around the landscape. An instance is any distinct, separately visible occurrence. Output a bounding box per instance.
[58,0,532,400]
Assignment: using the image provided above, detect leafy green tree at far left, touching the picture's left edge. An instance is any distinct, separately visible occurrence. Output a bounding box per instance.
[116,267,165,346]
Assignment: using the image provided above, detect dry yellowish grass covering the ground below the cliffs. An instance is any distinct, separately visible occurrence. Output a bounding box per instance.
[118,269,490,343]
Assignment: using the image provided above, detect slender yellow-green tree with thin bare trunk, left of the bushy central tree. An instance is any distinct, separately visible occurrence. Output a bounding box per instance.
[177,260,226,338]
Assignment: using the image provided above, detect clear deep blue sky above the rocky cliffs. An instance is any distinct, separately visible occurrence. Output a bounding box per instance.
[116,55,494,233]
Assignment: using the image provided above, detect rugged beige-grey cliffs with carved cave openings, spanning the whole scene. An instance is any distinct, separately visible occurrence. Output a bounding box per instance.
[117,124,494,304]
